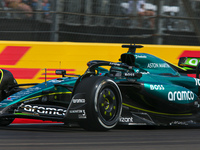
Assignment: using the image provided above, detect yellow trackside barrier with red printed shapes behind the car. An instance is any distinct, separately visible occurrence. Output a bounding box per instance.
[0,41,200,83]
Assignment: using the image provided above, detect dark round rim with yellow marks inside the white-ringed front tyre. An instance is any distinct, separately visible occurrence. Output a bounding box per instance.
[98,88,118,122]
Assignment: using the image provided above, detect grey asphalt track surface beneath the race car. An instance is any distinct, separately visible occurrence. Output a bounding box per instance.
[0,124,200,150]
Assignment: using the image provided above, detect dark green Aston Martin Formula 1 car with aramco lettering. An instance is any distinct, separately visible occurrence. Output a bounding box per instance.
[0,45,200,131]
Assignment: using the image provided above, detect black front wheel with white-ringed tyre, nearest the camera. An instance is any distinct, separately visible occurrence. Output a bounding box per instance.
[74,76,122,131]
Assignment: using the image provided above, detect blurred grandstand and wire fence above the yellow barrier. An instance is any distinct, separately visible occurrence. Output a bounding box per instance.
[0,0,200,46]
